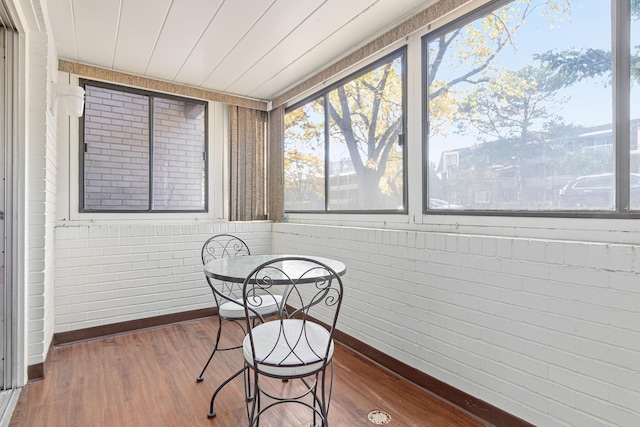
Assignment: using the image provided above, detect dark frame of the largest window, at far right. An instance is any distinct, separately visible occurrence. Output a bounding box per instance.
[420,0,640,219]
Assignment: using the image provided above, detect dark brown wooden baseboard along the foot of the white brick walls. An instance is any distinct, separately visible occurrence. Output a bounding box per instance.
[36,307,534,427]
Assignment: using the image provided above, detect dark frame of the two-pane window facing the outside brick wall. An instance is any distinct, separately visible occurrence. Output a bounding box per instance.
[77,78,211,216]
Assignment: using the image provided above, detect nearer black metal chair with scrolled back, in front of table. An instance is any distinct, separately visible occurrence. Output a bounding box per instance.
[243,256,343,427]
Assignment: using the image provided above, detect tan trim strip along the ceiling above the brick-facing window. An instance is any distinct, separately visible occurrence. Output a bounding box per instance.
[58,59,267,111]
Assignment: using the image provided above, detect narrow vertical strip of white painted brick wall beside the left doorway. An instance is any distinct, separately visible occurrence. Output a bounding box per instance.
[25,26,56,364]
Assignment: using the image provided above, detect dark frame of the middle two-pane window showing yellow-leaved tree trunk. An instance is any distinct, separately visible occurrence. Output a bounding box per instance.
[283,44,409,215]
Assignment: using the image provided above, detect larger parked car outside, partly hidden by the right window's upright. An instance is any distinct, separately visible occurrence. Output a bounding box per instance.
[559,173,640,209]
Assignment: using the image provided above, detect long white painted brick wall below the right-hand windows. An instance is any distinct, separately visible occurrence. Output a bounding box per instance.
[273,223,640,426]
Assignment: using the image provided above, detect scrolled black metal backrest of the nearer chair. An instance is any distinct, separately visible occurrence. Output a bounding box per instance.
[243,256,343,370]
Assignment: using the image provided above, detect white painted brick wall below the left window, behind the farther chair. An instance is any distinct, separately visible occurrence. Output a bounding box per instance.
[55,221,271,332]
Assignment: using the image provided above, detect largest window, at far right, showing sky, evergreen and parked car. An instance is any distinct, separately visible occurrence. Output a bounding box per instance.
[423,0,640,214]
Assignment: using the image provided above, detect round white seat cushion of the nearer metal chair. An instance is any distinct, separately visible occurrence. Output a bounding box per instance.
[242,319,333,376]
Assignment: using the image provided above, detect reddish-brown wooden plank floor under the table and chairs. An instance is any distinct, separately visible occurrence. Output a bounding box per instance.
[9,318,482,427]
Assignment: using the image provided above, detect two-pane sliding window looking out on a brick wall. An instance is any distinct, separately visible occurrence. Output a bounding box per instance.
[80,81,207,212]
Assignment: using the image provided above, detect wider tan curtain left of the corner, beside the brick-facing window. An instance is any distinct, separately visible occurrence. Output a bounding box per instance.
[229,106,268,221]
